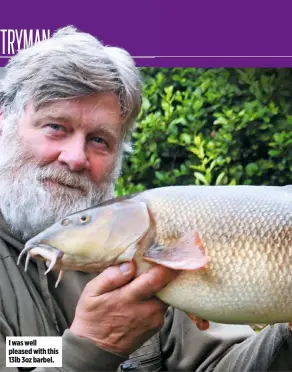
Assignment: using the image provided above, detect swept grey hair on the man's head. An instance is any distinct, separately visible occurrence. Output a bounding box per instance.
[0,26,142,151]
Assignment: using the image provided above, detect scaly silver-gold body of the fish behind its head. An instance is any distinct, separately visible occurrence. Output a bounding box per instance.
[138,187,292,323]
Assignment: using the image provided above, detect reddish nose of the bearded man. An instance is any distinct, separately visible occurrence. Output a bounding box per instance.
[58,138,89,172]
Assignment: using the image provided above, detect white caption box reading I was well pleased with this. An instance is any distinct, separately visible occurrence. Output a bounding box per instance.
[6,337,62,367]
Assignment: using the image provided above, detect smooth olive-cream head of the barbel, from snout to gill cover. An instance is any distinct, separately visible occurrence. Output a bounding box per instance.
[19,199,150,272]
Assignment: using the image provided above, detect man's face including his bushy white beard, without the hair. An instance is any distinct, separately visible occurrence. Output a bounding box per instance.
[0,93,122,239]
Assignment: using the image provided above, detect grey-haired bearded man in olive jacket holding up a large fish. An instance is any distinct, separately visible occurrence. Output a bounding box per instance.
[0,27,292,372]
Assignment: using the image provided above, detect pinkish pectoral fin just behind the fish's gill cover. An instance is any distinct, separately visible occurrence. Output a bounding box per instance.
[143,233,209,270]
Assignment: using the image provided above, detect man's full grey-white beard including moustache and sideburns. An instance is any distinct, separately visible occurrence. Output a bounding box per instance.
[0,127,121,241]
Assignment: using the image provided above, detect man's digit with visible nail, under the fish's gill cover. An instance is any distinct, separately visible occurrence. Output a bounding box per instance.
[84,262,135,297]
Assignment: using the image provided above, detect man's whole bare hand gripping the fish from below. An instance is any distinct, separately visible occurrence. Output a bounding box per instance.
[70,263,177,356]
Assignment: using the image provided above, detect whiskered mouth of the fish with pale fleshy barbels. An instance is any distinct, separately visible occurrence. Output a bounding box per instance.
[17,243,64,288]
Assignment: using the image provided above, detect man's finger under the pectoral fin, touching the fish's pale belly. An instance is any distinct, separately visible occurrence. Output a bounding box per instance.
[125,265,178,300]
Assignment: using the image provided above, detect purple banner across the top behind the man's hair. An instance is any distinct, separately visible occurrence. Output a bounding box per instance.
[0,0,292,67]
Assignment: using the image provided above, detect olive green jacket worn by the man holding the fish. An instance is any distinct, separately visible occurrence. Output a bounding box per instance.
[0,218,292,372]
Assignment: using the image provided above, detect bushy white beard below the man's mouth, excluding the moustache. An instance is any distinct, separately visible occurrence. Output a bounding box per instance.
[0,167,114,240]
